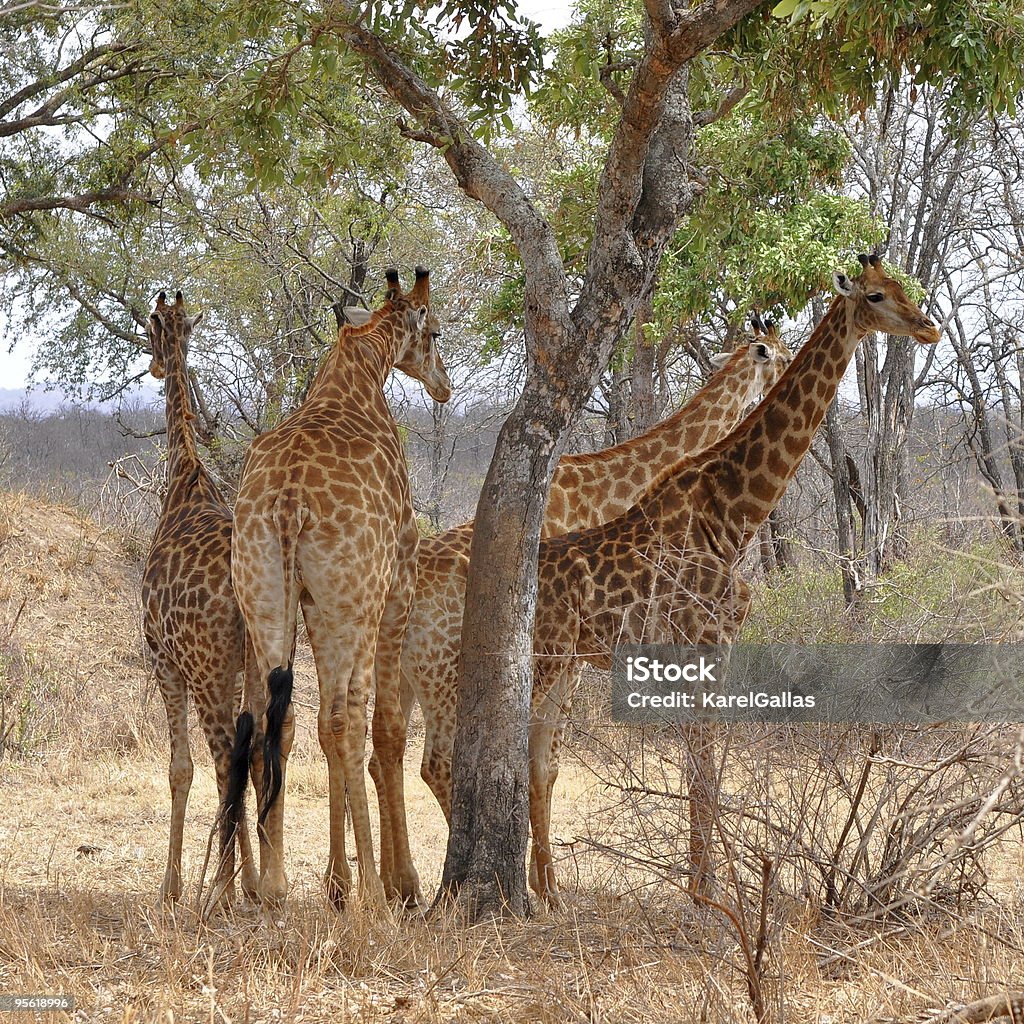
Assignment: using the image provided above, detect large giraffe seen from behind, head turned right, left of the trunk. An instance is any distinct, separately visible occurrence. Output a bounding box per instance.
[225,267,452,905]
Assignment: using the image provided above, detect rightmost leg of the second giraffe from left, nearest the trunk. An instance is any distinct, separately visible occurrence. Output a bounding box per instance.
[373,569,420,906]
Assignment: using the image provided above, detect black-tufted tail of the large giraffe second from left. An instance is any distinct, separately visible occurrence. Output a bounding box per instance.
[259,490,309,824]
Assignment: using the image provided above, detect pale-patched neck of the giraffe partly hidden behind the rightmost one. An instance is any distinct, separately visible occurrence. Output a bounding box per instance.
[566,349,757,486]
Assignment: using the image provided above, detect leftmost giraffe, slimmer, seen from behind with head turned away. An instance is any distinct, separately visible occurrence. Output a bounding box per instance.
[142,292,256,902]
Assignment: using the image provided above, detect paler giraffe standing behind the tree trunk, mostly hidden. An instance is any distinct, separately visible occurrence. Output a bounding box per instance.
[370,321,792,886]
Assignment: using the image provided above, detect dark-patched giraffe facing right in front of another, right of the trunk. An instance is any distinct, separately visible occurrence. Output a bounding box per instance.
[520,255,939,902]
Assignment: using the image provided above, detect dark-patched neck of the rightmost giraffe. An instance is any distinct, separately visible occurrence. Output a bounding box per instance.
[646,297,861,555]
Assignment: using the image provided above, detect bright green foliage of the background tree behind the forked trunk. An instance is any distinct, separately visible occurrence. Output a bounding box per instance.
[480,81,885,346]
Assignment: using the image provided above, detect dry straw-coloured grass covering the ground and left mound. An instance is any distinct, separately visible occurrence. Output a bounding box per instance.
[0,496,1024,1024]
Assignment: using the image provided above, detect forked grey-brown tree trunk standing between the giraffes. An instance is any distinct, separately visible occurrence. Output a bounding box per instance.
[333,0,770,919]
